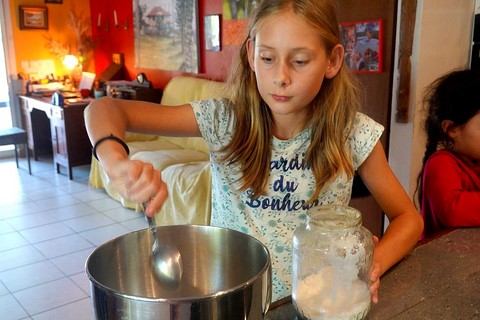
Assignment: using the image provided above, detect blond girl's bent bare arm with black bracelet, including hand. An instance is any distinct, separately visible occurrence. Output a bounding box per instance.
[85,97,200,215]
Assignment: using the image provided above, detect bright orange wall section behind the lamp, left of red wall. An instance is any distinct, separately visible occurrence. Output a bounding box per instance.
[9,0,95,76]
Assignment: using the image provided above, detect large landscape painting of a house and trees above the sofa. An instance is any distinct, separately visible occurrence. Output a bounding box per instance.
[133,0,200,73]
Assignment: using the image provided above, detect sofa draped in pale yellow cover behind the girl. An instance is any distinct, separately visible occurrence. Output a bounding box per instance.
[89,76,226,225]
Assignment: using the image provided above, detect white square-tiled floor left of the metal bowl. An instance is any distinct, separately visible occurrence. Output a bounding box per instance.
[0,158,146,320]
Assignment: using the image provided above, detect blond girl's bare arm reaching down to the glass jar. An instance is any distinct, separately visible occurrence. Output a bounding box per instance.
[358,142,423,302]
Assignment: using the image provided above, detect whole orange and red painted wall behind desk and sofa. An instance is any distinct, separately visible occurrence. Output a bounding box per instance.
[9,0,242,88]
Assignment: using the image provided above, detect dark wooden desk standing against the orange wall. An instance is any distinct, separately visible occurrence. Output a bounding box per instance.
[20,96,92,179]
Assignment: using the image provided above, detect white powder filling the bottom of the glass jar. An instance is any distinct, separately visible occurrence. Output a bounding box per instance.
[293,267,370,320]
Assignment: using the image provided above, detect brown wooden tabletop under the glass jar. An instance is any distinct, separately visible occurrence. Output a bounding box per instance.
[266,228,480,320]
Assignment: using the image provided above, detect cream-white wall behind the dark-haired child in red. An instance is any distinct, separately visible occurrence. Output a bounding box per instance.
[389,0,480,205]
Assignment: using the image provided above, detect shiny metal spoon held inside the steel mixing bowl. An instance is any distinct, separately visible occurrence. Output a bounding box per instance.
[142,203,183,287]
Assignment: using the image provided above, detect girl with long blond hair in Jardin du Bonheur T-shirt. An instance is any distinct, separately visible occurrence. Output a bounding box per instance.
[86,0,422,302]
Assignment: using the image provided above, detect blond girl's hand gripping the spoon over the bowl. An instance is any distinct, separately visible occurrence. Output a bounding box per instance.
[107,159,168,216]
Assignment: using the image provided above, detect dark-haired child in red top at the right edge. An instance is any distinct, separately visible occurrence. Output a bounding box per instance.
[417,70,480,236]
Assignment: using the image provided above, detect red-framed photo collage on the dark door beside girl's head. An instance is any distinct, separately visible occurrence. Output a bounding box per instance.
[340,20,383,73]
